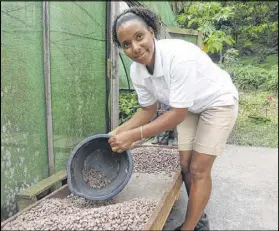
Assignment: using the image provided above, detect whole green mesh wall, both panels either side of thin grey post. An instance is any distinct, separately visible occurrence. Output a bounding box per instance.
[1,1,106,220]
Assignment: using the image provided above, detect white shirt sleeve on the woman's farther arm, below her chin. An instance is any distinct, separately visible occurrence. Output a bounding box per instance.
[132,81,157,107]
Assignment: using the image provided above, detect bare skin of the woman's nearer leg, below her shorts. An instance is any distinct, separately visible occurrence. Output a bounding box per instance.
[181,151,216,230]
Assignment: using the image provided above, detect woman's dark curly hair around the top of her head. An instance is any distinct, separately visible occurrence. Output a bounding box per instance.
[112,6,160,47]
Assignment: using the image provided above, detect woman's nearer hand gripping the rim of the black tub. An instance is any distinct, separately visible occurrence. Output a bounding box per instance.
[108,130,136,153]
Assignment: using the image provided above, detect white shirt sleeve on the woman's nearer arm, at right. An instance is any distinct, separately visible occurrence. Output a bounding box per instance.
[169,61,196,108]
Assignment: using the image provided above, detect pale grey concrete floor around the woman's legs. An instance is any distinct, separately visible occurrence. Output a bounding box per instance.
[164,145,278,230]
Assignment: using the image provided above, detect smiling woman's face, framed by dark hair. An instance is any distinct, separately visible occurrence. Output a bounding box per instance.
[117,20,154,66]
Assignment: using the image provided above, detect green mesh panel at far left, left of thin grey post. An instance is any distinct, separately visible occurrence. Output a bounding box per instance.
[1,2,48,220]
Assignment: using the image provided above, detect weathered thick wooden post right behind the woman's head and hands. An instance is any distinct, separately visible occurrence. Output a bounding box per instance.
[110,1,119,130]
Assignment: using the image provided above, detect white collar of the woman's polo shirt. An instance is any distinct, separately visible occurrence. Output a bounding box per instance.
[137,39,164,79]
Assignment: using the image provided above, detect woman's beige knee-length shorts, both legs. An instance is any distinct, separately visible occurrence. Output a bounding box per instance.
[177,100,238,155]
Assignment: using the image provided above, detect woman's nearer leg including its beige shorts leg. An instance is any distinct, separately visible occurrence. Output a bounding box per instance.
[181,101,238,230]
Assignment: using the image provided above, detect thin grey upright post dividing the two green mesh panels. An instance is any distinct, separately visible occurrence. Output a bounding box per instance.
[43,1,54,176]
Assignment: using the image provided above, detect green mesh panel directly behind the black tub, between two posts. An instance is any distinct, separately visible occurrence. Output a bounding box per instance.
[50,2,106,171]
